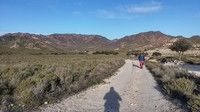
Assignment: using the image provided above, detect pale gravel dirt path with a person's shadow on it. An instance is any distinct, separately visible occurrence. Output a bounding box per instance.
[40,60,185,112]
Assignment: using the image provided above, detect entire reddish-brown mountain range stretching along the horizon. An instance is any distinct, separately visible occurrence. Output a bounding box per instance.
[0,31,200,53]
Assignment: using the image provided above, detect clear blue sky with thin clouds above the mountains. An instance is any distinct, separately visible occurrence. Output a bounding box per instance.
[0,0,200,39]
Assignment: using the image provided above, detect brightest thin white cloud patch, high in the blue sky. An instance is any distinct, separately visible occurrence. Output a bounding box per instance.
[122,2,162,14]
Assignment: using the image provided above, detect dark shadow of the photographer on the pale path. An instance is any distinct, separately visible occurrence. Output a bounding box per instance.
[103,87,122,112]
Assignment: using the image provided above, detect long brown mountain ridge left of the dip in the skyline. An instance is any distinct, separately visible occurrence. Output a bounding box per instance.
[0,33,111,51]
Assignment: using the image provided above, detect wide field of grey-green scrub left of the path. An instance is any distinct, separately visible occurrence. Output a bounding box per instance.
[0,54,124,111]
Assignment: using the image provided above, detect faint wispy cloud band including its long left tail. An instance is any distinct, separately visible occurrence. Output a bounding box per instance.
[72,1,162,19]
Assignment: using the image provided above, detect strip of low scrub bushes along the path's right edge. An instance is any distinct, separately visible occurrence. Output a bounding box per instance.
[146,62,200,112]
